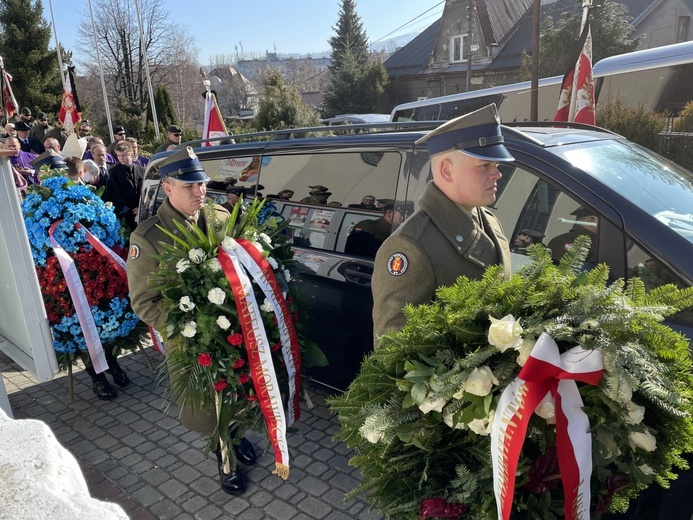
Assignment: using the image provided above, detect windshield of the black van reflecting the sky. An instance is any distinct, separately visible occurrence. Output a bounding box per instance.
[551,140,693,242]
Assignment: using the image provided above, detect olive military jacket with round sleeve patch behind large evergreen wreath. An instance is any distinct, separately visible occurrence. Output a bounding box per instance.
[372,182,510,345]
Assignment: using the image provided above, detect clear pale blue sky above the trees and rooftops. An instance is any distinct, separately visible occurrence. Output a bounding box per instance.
[42,0,445,64]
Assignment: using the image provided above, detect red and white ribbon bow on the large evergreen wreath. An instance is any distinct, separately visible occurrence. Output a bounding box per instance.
[491,333,604,520]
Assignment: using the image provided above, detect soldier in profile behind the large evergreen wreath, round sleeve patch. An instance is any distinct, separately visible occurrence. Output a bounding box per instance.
[372,105,514,346]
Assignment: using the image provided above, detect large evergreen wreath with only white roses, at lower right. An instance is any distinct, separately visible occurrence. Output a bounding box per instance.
[330,237,693,519]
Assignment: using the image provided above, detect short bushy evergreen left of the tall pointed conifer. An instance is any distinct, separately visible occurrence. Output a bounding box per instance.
[252,71,318,130]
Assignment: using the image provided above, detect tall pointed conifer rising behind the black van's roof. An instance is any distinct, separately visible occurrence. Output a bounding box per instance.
[324,0,391,116]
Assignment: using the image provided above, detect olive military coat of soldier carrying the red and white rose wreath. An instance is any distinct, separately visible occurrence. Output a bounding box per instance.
[127,199,229,435]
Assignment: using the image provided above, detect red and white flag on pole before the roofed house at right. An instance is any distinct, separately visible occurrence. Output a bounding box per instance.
[553,19,596,125]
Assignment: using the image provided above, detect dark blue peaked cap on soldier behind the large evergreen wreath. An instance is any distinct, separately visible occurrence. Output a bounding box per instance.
[416,103,515,161]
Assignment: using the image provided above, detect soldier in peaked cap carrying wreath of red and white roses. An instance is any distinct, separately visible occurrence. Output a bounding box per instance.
[127,147,256,495]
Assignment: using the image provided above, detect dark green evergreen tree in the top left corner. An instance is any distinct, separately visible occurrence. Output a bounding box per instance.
[0,0,63,113]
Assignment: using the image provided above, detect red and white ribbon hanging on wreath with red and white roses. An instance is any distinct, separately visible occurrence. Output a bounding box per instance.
[218,239,301,479]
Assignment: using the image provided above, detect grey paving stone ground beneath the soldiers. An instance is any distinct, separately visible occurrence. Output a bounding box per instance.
[0,348,383,520]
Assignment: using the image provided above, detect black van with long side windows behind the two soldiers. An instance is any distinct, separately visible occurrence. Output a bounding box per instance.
[139,122,693,390]
